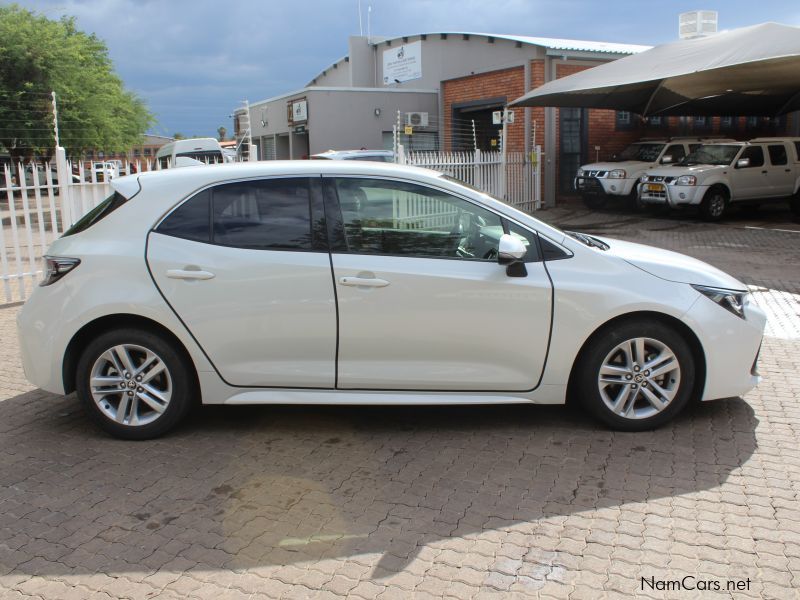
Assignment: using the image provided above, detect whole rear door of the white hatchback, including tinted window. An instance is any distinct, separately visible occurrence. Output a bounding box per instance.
[147,177,336,388]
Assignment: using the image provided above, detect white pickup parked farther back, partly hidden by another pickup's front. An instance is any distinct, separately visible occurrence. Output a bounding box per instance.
[575,138,733,208]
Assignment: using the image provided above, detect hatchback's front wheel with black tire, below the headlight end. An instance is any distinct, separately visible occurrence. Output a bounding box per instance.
[573,319,696,431]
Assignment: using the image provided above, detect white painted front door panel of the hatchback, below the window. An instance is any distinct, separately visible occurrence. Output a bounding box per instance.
[333,254,552,391]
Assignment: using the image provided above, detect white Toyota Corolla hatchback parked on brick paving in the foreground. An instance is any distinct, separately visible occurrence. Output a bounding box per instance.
[19,161,765,439]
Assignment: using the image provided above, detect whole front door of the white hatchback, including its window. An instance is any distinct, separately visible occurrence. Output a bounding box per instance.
[325,177,551,391]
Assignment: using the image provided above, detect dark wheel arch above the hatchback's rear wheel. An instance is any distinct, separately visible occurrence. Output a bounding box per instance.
[61,313,200,395]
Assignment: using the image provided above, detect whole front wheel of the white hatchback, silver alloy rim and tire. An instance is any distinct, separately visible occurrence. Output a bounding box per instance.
[575,320,695,431]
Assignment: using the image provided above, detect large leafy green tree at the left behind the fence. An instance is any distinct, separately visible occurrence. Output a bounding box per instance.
[0,4,153,158]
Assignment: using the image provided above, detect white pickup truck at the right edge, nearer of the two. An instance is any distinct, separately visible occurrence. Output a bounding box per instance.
[639,137,800,221]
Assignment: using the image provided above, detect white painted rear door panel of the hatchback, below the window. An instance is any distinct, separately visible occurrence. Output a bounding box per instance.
[147,232,336,388]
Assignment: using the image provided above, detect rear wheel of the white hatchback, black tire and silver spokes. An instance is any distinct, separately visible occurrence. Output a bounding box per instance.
[75,329,198,440]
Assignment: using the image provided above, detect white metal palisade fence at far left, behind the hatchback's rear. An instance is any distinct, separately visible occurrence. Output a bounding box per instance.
[0,151,151,305]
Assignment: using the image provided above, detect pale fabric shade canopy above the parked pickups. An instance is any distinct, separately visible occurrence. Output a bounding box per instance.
[511,23,800,116]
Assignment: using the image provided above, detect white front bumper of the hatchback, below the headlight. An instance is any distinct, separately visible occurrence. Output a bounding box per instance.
[683,295,767,400]
